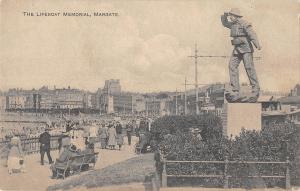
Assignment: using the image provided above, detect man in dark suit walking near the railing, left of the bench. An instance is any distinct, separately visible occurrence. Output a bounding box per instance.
[39,128,53,165]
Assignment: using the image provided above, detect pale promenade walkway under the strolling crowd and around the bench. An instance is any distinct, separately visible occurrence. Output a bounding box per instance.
[0,137,137,190]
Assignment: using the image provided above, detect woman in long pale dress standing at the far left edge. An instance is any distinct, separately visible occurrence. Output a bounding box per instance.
[7,136,25,174]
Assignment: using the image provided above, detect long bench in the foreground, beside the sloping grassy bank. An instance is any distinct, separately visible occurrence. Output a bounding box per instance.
[56,152,99,179]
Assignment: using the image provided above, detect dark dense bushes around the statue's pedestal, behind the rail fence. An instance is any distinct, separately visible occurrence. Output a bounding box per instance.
[151,115,300,187]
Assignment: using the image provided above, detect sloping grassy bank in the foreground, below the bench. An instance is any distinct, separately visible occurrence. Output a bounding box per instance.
[48,153,155,191]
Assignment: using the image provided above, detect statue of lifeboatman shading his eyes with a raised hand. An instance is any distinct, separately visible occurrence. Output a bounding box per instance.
[221,8,261,102]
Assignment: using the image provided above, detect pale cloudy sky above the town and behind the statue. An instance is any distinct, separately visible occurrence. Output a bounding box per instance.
[0,0,300,92]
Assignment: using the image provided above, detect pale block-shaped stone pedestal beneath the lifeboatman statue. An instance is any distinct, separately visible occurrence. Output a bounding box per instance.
[222,103,261,137]
